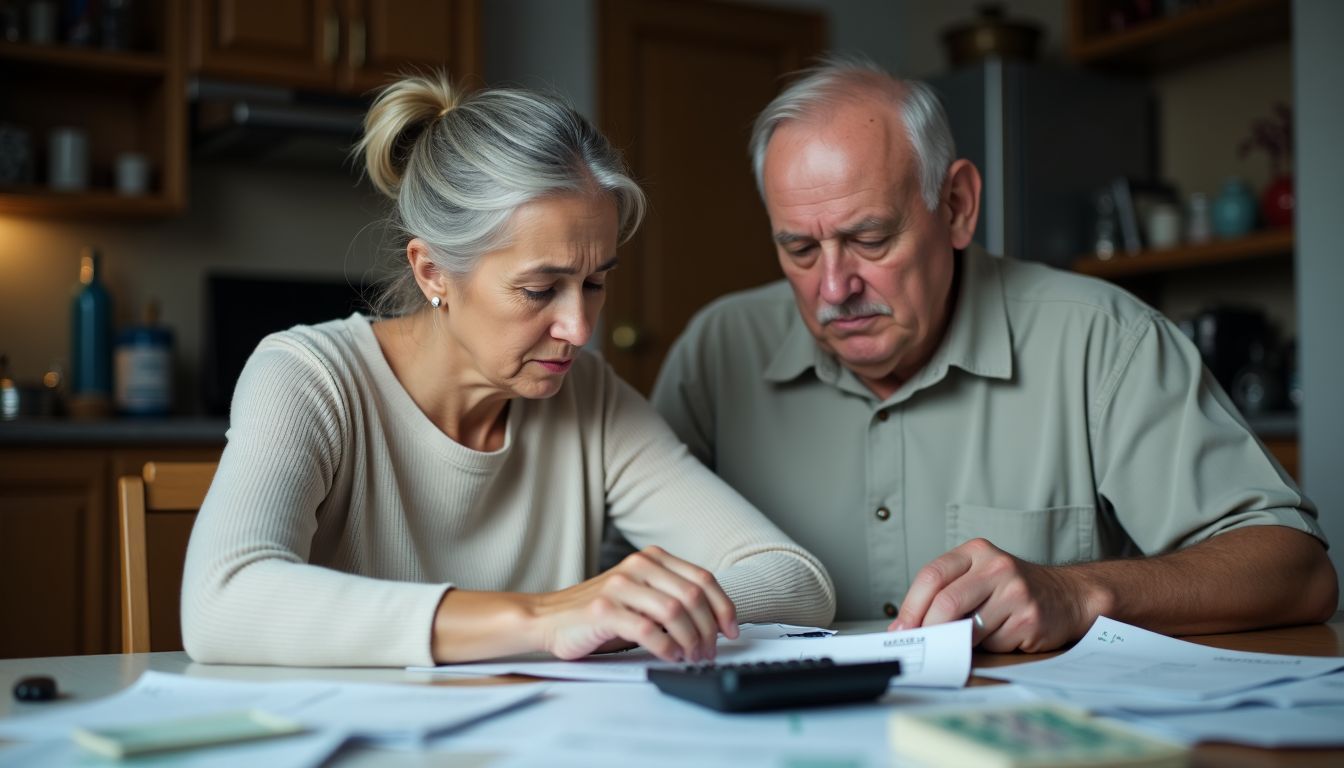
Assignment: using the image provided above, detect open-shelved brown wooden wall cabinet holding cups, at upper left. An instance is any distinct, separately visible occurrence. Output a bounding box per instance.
[0,0,187,217]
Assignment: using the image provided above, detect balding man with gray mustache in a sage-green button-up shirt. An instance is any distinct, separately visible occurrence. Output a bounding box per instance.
[653,61,1337,651]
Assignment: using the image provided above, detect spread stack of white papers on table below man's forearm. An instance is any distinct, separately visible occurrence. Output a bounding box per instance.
[977,617,1344,746]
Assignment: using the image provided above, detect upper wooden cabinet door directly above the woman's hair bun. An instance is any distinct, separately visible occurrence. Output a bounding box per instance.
[344,0,481,91]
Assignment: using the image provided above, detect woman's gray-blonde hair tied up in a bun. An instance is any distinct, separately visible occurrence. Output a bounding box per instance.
[355,73,645,315]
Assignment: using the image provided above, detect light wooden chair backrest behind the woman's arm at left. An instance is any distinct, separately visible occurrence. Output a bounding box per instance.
[117,461,218,654]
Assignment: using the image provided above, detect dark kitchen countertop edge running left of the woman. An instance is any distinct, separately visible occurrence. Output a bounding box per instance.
[0,417,228,448]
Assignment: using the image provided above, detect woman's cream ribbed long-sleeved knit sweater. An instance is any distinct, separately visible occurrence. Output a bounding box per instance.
[181,315,835,666]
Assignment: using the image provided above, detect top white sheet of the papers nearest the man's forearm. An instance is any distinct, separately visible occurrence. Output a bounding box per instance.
[977,616,1344,701]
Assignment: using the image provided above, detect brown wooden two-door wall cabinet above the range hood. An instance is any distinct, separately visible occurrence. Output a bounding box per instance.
[191,0,481,93]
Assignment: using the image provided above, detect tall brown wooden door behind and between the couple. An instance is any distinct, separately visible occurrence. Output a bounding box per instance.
[598,0,827,394]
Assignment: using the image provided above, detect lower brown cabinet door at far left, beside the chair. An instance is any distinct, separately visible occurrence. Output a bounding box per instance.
[0,449,108,658]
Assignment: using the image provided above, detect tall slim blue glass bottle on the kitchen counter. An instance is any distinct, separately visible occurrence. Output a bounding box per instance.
[70,247,112,408]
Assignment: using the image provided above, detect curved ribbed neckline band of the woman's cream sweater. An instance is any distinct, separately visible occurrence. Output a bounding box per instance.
[345,312,526,472]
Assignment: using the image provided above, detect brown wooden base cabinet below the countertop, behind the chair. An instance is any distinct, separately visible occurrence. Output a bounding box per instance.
[0,441,222,658]
